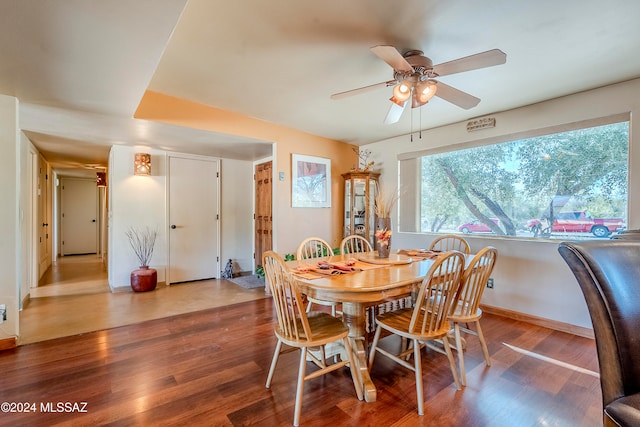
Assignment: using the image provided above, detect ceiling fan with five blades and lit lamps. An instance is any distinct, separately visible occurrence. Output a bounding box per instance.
[331,46,507,124]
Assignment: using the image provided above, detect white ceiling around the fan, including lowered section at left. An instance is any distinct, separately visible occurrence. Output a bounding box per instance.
[0,0,640,177]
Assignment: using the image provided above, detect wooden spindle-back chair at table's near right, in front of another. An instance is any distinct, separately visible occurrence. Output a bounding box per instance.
[369,251,465,415]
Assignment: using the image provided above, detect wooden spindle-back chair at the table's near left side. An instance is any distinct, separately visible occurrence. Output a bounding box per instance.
[262,251,363,426]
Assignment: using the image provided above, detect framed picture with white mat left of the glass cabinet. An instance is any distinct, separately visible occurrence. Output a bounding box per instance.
[291,154,331,208]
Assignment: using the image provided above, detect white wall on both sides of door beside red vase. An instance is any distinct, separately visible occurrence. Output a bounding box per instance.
[108,146,253,289]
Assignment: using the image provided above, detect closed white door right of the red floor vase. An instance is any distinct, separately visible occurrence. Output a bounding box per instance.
[168,156,220,283]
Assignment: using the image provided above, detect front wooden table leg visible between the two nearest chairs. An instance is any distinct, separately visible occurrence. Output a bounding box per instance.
[342,302,376,402]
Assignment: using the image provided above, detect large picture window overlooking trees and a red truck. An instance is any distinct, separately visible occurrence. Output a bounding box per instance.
[399,121,629,239]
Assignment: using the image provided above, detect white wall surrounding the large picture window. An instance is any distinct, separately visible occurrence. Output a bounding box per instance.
[361,79,640,328]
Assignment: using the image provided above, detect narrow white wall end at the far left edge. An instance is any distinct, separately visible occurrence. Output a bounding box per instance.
[0,95,22,339]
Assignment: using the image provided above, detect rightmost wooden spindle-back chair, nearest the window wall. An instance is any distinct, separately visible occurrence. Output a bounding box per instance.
[449,246,498,385]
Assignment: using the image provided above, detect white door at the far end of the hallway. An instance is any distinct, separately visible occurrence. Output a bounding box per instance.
[60,178,98,255]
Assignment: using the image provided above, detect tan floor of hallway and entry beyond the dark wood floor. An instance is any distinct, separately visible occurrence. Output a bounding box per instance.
[18,255,264,345]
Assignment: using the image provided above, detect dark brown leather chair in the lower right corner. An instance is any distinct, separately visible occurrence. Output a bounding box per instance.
[558,240,640,426]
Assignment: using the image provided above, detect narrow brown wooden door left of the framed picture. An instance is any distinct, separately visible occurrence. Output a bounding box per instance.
[254,162,273,265]
